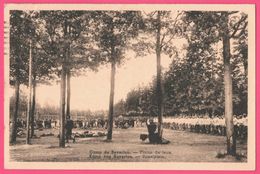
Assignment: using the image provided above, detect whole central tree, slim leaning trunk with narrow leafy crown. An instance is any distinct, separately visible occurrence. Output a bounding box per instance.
[95,11,141,141]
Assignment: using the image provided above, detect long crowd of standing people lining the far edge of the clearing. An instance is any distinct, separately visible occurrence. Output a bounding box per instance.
[10,115,248,139]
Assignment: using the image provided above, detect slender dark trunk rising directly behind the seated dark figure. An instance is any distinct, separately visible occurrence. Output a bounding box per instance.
[156,11,163,138]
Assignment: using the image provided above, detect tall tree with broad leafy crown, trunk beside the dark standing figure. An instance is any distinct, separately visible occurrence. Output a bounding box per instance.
[41,11,103,147]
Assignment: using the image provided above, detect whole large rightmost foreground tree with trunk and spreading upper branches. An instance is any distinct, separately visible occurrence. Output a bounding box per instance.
[184,11,247,155]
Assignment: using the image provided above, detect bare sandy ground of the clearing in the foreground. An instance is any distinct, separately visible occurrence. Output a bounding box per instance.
[10,127,247,162]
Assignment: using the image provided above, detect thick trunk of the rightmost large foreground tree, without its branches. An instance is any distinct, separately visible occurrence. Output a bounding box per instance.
[222,13,236,155]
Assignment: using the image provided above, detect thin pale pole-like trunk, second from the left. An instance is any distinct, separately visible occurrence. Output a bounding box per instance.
[26,41,32,144]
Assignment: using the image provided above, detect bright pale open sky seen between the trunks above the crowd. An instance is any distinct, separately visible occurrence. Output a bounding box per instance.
[36,52,172,110]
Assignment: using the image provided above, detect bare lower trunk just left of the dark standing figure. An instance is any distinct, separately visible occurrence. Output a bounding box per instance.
[59,65,66,147]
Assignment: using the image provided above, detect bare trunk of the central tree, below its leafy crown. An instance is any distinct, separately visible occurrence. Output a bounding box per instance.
[107,58,116,141]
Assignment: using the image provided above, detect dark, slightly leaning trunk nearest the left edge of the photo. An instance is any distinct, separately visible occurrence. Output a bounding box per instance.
[10,79,20,144]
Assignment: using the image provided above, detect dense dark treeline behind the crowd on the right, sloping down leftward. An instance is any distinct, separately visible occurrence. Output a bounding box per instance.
[115,38,248,117]
